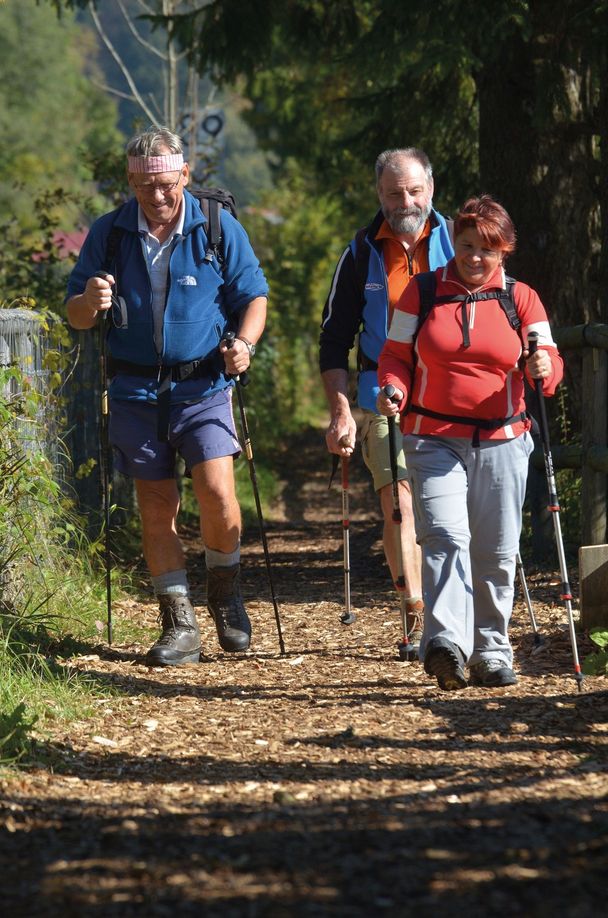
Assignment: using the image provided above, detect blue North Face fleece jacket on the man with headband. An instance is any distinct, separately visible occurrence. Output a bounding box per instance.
[67,191,268,402]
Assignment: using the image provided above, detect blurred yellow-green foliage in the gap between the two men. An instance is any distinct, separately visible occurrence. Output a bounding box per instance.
[243,163,345,442]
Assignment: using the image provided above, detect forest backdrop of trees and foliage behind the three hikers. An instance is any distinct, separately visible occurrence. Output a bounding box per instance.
[0,0,608,664]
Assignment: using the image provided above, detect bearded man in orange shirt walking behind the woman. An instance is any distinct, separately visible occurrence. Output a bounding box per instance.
[319,147,454,653]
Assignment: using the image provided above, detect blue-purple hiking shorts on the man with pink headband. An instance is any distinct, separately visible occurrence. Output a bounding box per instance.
[109,388,241,481]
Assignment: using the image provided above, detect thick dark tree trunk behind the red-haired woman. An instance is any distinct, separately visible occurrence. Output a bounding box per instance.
[476,0,601,325]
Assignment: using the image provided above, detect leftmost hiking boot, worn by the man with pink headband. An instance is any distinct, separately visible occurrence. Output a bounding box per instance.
[146,593,201,666]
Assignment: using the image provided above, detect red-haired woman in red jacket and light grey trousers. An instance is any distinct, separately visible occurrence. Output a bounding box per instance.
[377,195,563,690]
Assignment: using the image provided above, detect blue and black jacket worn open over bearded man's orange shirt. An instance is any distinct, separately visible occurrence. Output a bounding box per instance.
[319,210,454,412]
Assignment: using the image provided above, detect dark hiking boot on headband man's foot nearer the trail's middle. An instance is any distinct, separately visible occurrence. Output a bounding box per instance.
[207,564,251,651]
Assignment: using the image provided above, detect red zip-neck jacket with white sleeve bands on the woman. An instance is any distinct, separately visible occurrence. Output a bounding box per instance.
[378,259,563,440]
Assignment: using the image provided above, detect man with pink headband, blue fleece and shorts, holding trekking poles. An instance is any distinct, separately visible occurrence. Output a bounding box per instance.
[67,126,268,666]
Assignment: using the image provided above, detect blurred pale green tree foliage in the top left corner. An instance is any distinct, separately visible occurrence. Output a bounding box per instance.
[0,0,119,229]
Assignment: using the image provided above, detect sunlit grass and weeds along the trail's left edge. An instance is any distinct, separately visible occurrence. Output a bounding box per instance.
[0,352,116,764]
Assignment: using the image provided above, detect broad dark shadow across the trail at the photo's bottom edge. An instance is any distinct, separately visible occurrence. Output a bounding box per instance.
[2,763,608,918]
